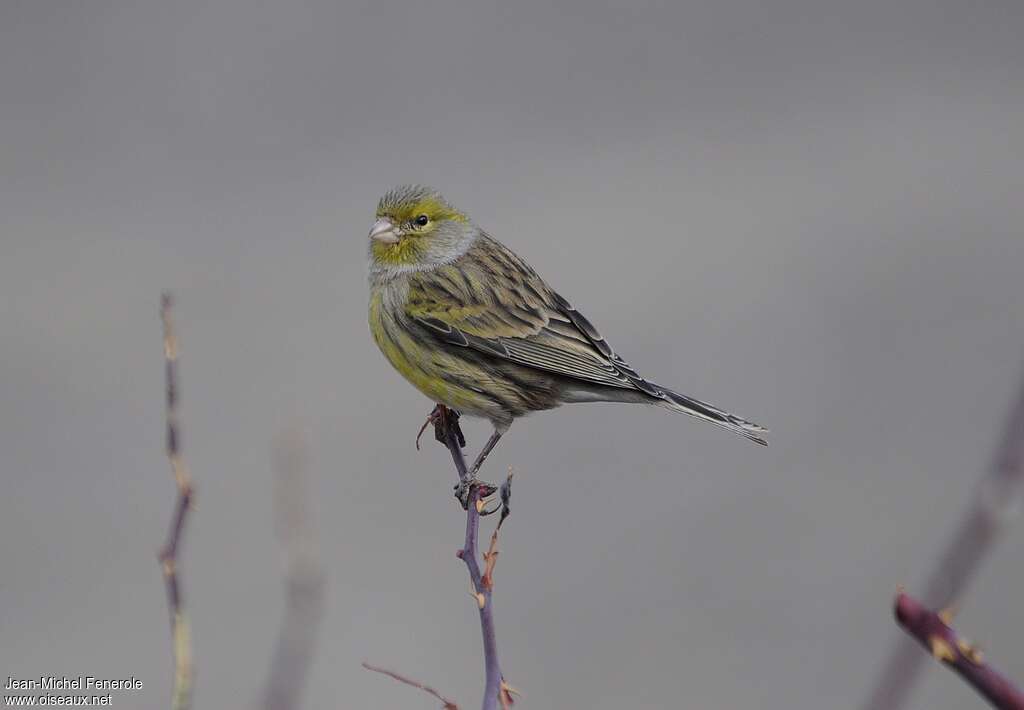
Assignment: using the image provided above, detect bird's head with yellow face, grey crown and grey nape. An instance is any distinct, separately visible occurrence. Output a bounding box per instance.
[370,184,479,272]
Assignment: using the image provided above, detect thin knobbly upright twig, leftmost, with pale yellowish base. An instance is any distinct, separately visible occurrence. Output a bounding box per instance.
[160,293,193,710]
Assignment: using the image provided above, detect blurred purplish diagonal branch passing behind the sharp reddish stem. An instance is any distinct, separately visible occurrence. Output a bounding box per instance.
[863,368,1024,710]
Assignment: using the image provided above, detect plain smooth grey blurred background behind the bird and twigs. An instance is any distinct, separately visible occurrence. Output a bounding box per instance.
[0,0,1024,710]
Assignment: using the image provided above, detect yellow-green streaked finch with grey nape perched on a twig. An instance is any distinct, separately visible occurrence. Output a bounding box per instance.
[368,184,768,481]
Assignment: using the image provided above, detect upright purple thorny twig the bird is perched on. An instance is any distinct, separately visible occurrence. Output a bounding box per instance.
[434,405,514,710]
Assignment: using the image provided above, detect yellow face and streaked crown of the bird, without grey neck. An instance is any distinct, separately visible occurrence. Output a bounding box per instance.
[370,187,469,265]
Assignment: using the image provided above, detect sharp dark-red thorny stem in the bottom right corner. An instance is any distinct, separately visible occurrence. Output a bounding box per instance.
[896,591,1024,710]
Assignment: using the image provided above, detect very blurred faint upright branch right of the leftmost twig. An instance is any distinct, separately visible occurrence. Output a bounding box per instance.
[263,430,325,710]
